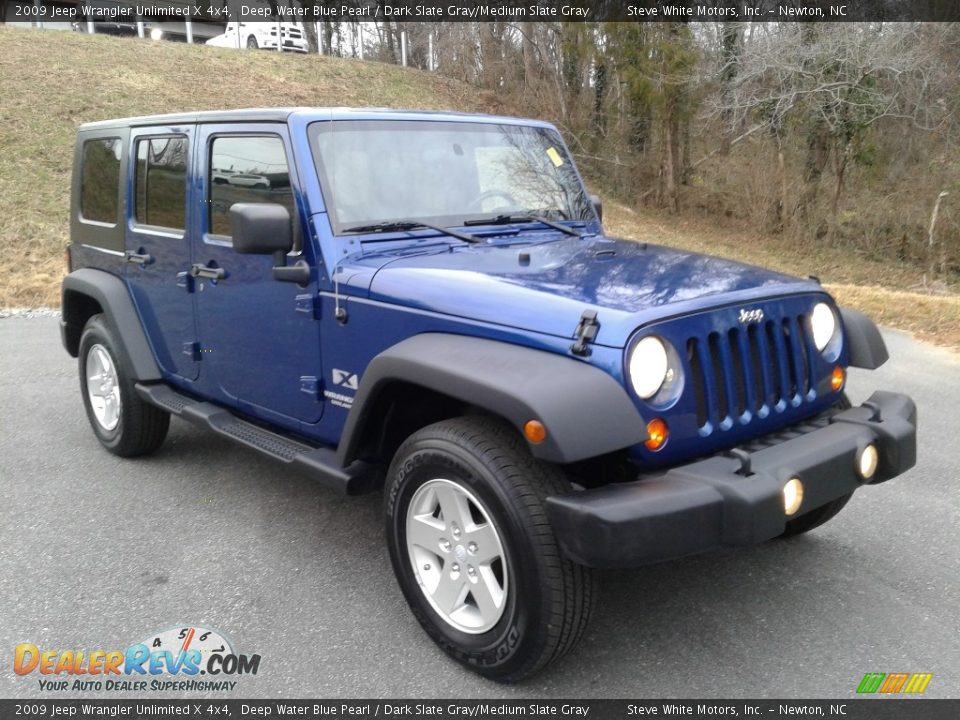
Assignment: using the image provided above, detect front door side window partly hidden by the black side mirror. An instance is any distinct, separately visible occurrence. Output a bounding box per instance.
[208,135,295,235]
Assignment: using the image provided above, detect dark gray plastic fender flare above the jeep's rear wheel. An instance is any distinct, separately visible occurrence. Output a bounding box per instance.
[60,268,161,382]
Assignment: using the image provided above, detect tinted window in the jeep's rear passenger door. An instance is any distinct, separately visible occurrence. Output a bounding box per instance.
[134,135,187,230]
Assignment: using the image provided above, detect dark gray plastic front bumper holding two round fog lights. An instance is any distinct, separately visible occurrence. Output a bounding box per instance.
[547,391,917,567]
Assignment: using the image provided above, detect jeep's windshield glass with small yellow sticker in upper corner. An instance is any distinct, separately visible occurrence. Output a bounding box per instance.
[310,120,593,233]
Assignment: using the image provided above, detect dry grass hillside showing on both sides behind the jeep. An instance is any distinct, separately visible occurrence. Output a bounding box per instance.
[0,26,960,348]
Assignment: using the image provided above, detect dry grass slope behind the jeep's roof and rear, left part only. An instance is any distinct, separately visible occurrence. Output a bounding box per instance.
[0,25,503,308]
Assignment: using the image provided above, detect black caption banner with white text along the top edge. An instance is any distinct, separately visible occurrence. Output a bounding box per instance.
[16,0,960,23]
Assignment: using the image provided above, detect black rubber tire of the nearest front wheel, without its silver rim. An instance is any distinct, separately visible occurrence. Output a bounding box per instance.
[384,417,597,682]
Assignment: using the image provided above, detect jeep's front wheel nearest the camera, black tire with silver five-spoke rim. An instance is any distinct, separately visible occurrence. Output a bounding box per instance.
[384,417,597,682]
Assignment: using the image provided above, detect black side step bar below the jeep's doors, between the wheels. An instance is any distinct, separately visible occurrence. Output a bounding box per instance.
[136,383,380,495]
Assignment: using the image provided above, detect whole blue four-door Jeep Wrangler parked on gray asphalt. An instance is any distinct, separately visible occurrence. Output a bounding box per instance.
[61,108,916,681]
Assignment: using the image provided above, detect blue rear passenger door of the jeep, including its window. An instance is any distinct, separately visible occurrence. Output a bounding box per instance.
[125,125,200,380]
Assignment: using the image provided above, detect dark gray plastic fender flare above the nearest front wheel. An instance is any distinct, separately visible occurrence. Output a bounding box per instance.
[338,333,647,465]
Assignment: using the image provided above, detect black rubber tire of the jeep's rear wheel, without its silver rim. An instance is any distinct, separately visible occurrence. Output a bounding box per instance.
[78,315,170,457]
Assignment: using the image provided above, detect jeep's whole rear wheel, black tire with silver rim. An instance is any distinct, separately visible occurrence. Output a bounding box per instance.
[79,315,170,457]
